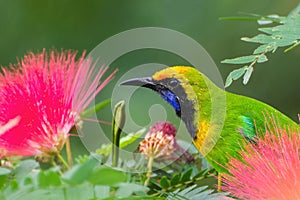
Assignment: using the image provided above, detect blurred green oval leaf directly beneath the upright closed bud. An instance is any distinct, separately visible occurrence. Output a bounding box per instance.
[89,167,127,186]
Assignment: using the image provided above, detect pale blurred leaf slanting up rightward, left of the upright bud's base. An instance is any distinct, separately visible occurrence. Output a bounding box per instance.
[62,157,99,185]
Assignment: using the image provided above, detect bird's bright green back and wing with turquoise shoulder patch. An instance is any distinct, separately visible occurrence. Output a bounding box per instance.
[206,92,299,172]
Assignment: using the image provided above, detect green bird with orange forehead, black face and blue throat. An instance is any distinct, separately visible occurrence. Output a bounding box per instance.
[122,66,298,173]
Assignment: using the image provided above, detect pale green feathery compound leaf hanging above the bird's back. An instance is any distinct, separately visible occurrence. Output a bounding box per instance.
[222,8,300,87]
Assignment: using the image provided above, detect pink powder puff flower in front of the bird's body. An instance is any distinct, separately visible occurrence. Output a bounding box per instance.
[222,123,300,200]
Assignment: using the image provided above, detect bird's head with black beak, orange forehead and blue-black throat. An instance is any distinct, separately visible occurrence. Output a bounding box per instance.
[121,66,213,139]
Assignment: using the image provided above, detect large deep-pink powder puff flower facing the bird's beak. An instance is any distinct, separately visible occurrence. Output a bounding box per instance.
[0,50,116,156]
